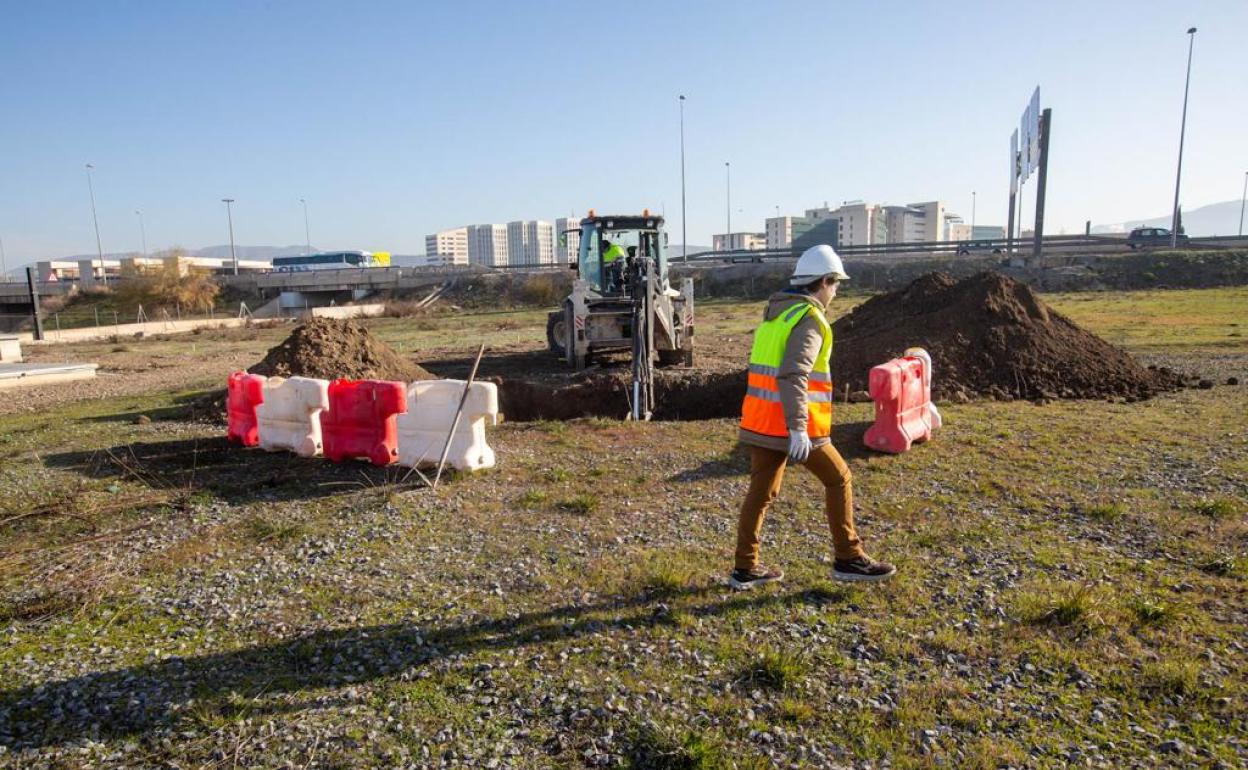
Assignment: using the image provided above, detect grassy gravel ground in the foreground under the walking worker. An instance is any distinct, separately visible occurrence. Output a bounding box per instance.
[0,295,1248,770]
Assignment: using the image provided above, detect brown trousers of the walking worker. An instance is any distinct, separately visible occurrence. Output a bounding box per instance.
[736,443,864,569]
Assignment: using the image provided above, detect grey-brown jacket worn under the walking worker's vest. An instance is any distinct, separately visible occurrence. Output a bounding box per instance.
[738,292,830,452]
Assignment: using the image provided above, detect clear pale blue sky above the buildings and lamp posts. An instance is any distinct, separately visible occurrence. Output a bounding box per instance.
[0,0,1248,260]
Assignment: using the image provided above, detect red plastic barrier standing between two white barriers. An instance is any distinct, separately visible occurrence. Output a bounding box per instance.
[321,379,407,465]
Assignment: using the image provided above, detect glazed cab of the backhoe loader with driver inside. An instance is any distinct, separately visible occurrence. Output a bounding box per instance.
[577,210,668,297]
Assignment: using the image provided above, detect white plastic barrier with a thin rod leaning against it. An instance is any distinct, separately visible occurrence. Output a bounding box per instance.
[398,379,498,470]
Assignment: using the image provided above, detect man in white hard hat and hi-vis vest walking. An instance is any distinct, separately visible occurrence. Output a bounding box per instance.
[729,246,896,589]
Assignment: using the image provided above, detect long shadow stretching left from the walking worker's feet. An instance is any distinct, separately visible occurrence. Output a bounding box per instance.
[0,585,846,749]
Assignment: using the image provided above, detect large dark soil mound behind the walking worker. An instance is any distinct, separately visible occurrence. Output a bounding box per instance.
[832,272,1183,399]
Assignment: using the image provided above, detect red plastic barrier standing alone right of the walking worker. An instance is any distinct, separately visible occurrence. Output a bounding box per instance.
[862,348,941,454]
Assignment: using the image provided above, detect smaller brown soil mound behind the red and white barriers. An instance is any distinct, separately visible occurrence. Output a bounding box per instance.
[247,318,434,382]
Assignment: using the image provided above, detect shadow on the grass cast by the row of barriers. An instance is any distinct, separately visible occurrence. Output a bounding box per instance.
[42,437,419,504]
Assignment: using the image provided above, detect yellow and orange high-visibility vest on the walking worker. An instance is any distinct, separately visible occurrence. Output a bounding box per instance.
[741,302,832,438]
